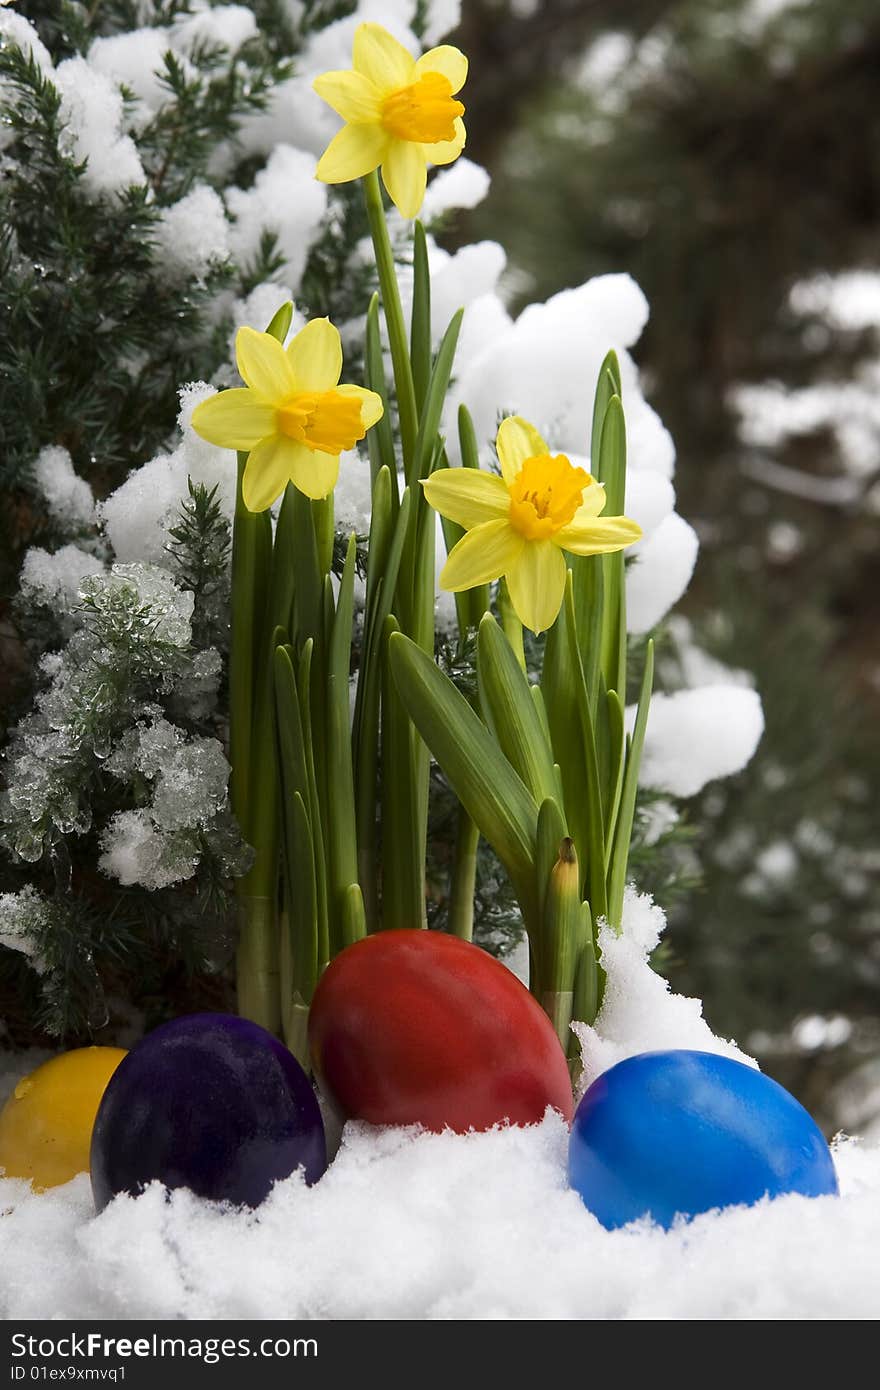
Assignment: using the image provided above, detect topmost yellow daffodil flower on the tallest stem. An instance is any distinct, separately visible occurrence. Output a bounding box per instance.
[313,24,467,217]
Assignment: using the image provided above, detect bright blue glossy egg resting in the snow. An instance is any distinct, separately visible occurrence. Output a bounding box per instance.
[569,1049,837,1230]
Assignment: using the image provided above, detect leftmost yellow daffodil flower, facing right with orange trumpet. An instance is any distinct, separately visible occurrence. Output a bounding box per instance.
[192,318,384,512]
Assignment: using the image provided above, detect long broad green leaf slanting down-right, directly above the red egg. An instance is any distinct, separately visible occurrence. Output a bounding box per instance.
[388,632,538,902]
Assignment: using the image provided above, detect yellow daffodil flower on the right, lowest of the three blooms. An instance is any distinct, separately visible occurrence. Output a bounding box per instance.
[423,416,642,632]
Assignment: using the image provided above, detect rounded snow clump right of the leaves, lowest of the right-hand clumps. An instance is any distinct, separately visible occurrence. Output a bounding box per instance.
[627,685,763,796]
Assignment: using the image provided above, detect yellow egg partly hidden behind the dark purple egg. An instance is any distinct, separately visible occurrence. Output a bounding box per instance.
[0,1047,125,1191]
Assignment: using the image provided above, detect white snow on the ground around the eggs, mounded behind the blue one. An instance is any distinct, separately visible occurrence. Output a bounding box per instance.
[0,892,880,1321]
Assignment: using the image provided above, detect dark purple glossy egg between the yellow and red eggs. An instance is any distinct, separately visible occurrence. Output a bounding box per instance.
[90,1013,327,1211]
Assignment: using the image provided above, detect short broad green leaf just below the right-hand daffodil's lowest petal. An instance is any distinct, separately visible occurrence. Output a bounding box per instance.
[477,613,556,805]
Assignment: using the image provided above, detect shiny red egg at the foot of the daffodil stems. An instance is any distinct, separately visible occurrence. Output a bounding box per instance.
[309,930,573,1133]
